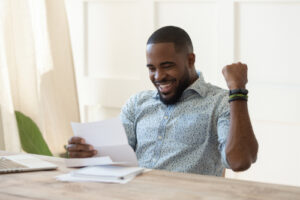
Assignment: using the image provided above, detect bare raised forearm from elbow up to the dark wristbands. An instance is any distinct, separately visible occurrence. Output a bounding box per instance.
[226,101,258,171]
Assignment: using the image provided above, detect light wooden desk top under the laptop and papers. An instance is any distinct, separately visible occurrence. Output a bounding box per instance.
[0,151,300,200]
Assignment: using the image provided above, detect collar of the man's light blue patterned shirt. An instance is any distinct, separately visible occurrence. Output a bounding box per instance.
[153,72,207,99]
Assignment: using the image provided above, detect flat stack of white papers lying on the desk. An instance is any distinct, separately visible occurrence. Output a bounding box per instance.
[56,166,144,183]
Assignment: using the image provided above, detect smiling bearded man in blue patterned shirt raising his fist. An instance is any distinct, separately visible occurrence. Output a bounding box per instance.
[68,26,258,176]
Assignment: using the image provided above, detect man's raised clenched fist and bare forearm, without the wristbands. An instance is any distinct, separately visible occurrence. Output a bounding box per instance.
[222,62,258,171]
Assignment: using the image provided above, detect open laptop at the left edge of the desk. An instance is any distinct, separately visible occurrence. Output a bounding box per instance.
[0,154,57,174]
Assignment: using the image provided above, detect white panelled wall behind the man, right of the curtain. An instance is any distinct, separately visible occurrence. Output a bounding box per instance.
[67,0,300,186]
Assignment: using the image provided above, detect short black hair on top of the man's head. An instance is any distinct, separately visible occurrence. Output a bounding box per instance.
[147,26,194,53]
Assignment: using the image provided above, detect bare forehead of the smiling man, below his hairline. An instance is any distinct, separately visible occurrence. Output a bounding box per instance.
[146,42,177,59]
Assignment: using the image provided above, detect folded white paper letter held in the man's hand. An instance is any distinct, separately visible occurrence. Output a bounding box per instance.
[66,118,138,167]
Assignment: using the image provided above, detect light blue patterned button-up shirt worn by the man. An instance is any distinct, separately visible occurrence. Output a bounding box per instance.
[121,75,230,176]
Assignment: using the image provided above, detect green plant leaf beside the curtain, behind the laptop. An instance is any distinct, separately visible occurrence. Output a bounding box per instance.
[15,111,52,156]
